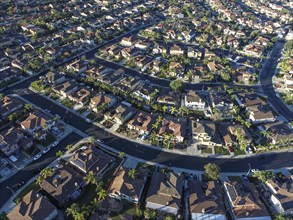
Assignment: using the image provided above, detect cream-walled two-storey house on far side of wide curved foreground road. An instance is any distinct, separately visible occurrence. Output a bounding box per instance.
[191,121,221,146]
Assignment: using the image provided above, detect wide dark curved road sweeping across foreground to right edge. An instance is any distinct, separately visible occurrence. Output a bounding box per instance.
[15,89,293,172]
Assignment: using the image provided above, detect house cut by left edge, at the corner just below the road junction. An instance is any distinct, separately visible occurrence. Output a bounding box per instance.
[0,96,23,119]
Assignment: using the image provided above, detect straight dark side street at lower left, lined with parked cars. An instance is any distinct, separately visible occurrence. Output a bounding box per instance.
[0,132,82,207]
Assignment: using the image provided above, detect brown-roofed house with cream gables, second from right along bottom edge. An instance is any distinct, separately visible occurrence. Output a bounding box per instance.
[224,181,271,220]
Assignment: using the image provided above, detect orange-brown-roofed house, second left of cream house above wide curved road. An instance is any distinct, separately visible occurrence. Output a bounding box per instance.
[127,111,157,134]
